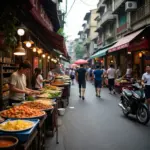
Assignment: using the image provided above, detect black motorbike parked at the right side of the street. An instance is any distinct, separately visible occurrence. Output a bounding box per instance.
[119,83,149,124]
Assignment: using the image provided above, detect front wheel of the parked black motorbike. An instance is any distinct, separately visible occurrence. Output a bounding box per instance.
[136,105,150,125]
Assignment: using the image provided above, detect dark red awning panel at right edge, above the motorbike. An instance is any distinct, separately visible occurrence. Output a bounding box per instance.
[128,40,149,51]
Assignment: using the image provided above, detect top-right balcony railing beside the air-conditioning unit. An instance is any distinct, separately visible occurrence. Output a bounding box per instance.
[131,2,150,25]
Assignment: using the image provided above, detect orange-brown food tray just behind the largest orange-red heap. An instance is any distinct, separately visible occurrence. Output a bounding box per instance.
[22,102,53,110]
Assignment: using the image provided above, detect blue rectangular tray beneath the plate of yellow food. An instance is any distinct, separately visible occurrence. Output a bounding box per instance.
[0,119,40,143]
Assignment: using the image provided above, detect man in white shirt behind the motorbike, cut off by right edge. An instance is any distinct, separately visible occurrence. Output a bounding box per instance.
[142,66,150,104]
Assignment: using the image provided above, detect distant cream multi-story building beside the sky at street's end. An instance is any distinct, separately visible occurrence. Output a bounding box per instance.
[83,9,97,57]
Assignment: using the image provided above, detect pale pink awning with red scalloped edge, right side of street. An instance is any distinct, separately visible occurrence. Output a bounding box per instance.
[108,29,144,53]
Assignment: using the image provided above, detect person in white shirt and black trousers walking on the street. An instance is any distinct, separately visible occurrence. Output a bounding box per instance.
[107,64,116,94]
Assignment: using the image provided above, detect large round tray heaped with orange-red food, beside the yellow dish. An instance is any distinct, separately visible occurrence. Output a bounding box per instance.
[0,105,46,119]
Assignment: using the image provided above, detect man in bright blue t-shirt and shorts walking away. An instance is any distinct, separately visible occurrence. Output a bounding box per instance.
[93,66,103,97]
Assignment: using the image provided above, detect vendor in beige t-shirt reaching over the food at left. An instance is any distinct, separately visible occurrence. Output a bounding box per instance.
[9,61,40,105]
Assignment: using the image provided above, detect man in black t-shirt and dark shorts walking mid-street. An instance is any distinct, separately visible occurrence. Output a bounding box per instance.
[76,65,87,100]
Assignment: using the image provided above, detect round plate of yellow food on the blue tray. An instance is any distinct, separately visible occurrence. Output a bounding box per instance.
[0,119,34,132]
